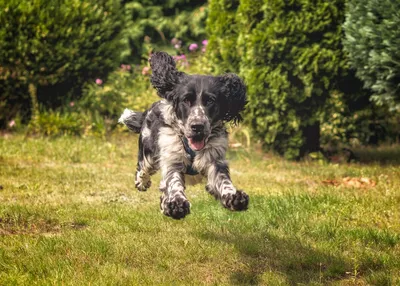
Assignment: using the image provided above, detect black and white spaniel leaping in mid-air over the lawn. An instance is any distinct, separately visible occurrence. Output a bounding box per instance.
[119,52,249,219]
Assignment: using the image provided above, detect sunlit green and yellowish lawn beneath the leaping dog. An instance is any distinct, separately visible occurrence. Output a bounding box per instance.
[0,135,400,285]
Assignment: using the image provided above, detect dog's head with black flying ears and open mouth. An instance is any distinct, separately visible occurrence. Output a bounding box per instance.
[150,52,247,151]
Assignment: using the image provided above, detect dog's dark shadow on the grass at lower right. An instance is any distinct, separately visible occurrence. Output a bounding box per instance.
[201,231,351,285]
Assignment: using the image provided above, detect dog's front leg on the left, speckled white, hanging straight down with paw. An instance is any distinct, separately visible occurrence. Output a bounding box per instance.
[160,165,190,219]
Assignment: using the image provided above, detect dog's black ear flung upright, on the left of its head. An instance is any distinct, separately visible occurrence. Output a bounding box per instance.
[149,52,185,99]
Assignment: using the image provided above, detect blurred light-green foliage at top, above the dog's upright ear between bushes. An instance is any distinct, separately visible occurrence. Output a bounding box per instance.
[123,0,207,63]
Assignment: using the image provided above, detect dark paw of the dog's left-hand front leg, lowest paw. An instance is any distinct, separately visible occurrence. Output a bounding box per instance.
[160,195,190,219]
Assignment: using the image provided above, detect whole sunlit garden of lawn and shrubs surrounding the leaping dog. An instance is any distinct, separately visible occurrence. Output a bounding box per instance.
[0,0,400,285]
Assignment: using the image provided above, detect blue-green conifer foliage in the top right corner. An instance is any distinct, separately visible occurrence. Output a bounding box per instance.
[343,0,400,111]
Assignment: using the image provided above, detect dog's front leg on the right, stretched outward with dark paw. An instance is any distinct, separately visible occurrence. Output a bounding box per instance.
[206,161,249,211]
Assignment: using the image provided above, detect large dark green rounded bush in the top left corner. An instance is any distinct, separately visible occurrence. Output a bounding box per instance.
[0,0,124,126]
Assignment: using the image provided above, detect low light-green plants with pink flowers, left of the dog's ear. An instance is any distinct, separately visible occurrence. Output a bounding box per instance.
[28,65,158,137]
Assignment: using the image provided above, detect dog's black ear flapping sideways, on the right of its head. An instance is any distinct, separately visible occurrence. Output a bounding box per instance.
[218,73,247,124]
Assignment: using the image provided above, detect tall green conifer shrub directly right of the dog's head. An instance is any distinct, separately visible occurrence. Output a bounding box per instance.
[208,0,360,159]
